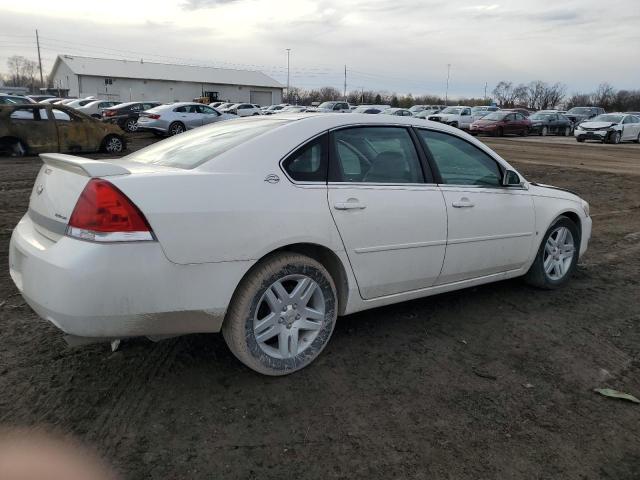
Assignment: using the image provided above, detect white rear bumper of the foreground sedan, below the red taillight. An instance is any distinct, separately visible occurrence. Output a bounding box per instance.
[9,216,252,338]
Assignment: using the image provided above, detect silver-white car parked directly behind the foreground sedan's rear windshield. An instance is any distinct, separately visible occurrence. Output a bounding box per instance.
[138,102,237,136]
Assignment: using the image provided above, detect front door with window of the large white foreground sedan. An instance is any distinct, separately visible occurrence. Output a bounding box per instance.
[418,129,535,284]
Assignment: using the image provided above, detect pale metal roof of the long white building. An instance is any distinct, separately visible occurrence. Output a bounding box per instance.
[51,55,284,88]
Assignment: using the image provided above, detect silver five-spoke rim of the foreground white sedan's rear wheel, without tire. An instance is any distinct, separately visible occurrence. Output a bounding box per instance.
[253,274,325,359]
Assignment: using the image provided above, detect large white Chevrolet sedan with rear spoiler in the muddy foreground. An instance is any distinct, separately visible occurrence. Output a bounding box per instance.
[10,114,591,375]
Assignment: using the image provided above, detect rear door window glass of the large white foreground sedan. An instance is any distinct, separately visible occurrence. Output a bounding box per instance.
[330,127,424,184]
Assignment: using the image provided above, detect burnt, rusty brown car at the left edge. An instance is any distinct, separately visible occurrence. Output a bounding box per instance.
[0,103,126,156]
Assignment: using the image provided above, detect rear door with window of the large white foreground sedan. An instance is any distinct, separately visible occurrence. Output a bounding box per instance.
[328,126,447,299]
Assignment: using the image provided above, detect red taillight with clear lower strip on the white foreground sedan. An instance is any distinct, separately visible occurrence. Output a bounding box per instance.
[67,178,154,242]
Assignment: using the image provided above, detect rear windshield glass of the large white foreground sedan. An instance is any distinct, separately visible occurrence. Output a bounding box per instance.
[125,117,291,169]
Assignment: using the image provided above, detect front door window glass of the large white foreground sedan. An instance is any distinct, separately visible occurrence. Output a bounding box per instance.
[418,129,502,187]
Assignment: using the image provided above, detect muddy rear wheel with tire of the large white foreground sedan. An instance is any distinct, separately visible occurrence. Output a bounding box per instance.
[222,252,337,376]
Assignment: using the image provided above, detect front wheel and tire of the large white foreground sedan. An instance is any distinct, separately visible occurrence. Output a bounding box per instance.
[525,215,580,290]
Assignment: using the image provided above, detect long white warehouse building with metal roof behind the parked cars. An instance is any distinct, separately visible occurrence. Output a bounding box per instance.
[49,55,284,105]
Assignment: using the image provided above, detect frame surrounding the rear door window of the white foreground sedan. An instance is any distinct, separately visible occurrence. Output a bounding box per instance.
[327,123,436,188]
